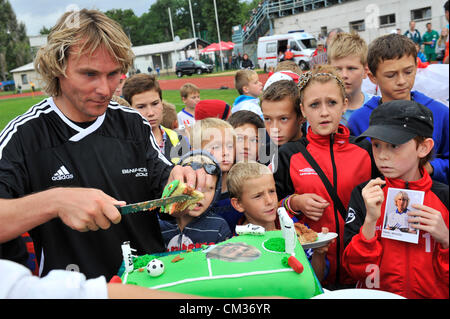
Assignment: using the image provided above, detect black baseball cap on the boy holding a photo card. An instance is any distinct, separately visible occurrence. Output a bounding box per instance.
[358,100,433,145]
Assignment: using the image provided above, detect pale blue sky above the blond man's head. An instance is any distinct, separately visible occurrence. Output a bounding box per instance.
[9,0,156,35]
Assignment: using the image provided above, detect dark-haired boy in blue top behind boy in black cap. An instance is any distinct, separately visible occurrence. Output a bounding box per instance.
[348,34,449,185]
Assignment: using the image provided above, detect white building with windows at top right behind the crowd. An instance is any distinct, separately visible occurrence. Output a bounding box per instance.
[273,0,448,43]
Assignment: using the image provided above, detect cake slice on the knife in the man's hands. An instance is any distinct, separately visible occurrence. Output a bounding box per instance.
[161,180,204,215]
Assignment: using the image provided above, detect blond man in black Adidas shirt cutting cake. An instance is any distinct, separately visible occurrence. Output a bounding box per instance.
[0,9,205,280]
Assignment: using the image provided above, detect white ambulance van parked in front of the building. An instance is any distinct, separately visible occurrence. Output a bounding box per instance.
[258,30,317,70]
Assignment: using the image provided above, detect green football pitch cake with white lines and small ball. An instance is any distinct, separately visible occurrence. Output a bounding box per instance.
[119,209,323,298]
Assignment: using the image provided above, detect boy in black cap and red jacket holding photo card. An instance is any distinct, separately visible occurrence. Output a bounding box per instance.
[342,100,449,299]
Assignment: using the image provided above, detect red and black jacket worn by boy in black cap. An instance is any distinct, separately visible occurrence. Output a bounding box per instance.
[342,170,449,299]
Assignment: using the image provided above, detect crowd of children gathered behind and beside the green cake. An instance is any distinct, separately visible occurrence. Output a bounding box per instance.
[5,24,449,298]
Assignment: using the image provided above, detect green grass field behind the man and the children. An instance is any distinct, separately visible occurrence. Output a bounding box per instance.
[0,89,238,131]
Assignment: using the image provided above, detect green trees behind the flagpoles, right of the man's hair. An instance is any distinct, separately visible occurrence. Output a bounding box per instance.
[105,0,259,46]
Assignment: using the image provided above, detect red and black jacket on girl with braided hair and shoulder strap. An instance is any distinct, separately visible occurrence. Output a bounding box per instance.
[273,125,379,284]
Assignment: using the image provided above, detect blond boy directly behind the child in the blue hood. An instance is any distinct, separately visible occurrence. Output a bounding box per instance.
[190,117,240,230]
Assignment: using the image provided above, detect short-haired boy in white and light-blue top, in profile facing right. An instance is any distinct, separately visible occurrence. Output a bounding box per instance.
[231,69,263,118]
